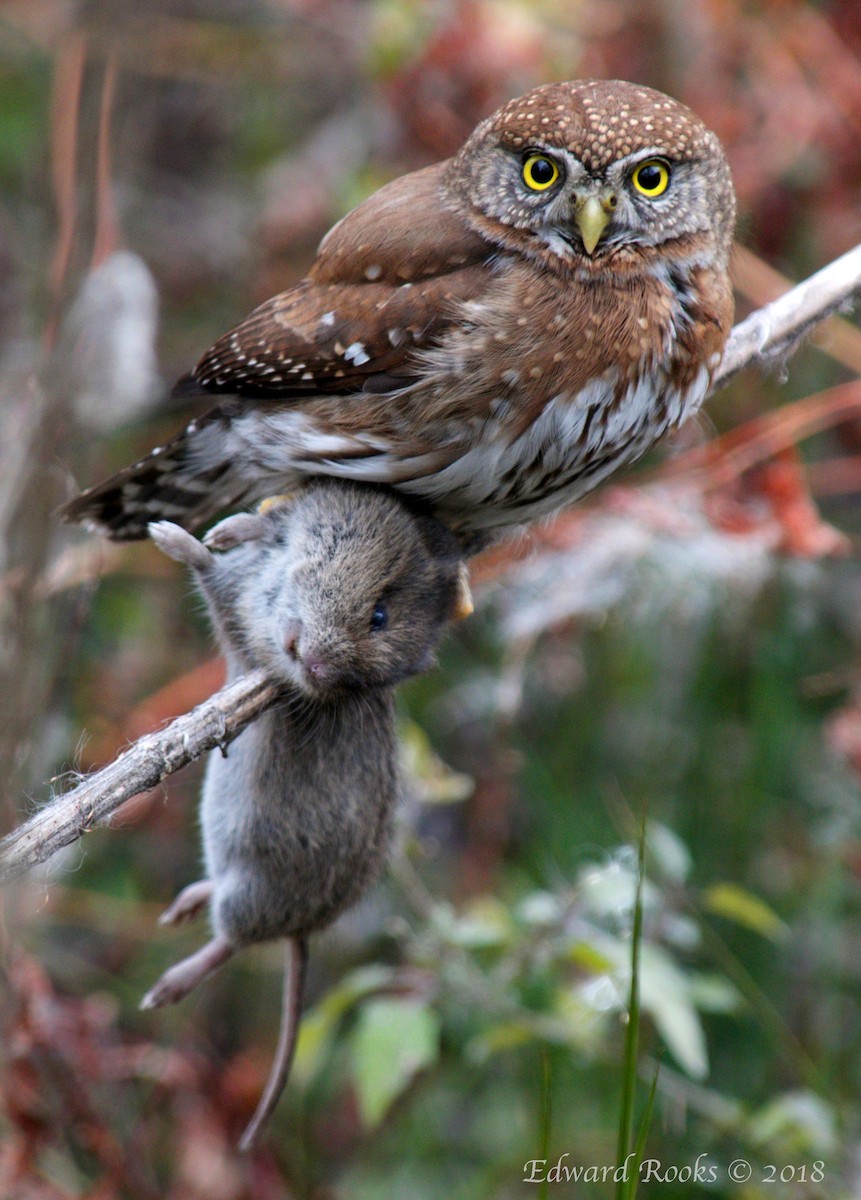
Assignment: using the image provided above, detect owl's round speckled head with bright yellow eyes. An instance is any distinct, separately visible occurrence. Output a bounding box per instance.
[446,79,735,272]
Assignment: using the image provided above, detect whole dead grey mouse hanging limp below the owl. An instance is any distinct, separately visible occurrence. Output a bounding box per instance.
[142,481,469,1150]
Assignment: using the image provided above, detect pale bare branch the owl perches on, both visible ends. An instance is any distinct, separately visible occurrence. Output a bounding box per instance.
[0,246,861,883]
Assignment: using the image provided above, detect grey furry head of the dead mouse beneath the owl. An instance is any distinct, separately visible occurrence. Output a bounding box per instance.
[241,481,463,698]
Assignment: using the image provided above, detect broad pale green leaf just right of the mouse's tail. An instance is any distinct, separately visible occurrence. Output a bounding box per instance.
[353,998,439,1128]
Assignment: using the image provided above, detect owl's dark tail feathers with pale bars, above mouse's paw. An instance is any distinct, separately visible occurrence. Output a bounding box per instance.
[61,422,247,541]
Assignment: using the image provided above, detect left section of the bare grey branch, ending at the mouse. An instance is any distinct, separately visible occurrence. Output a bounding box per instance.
[0,671,281,883]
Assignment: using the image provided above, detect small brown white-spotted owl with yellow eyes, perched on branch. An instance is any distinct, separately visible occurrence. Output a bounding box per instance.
[66,80,735,545]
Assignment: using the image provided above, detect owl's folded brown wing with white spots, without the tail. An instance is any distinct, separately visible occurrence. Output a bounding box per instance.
[192,163,492,400]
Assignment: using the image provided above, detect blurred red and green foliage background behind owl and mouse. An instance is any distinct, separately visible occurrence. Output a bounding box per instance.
[0,0,861,1200]
